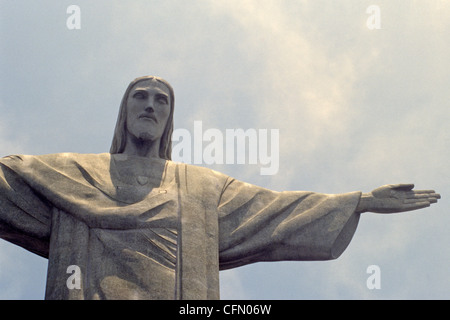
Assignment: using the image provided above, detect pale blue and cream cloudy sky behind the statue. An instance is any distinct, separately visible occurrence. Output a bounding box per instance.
[0,0,450,300]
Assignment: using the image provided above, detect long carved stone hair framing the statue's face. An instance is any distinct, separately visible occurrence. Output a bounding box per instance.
[109,76,175,160]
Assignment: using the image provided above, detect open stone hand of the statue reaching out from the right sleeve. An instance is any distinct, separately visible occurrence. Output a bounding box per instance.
[356,184,441,213]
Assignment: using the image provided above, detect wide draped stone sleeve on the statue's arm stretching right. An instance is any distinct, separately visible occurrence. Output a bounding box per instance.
[218,178,361,270]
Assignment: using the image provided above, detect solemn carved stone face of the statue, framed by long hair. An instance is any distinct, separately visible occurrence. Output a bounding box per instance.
[127,79,170,141]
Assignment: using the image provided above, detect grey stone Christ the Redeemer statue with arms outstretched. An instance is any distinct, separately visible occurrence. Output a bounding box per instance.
[0,77,440,299]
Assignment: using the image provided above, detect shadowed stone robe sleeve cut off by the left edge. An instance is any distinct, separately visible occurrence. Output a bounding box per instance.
[0,156,52,257]
